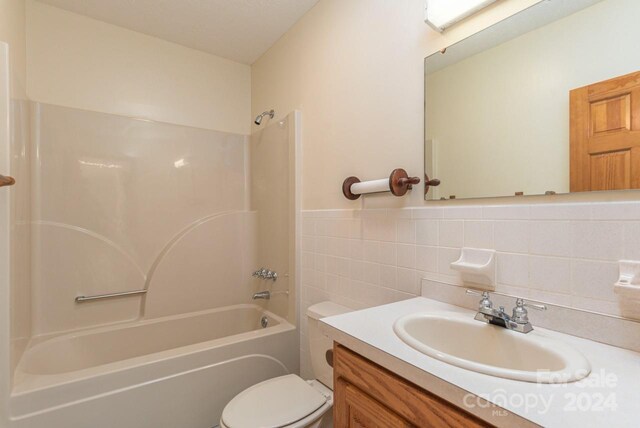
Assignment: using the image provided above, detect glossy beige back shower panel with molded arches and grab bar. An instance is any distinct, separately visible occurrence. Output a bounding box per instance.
[31,104,254,334]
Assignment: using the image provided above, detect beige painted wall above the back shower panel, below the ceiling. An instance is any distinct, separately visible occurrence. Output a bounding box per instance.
[27,0,251,135]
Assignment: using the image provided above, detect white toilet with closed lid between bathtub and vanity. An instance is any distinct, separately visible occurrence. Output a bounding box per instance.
[220,302,351,428]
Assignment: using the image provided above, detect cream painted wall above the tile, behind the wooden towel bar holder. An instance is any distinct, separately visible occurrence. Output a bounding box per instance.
[251,0,538,209]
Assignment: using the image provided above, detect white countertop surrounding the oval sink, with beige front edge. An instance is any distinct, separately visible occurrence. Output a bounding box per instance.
[321,297,640,428]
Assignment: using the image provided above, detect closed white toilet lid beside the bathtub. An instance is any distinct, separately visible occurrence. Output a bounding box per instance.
[222,375,327,428]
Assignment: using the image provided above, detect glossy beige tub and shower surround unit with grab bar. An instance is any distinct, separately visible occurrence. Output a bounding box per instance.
[8,106,301,428]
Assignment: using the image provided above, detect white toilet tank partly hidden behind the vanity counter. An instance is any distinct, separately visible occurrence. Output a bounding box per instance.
[307,302,352,389]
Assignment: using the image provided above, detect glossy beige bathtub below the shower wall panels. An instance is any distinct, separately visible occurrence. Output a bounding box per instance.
[10,305,298,428]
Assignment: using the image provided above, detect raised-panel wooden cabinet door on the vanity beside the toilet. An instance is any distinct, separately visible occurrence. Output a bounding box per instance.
[336,380,412,428]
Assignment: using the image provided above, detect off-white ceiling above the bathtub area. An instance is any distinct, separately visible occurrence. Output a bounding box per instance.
[38,0,318,64]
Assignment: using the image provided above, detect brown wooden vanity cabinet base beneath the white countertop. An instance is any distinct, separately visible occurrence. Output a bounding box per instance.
[333,343,491,428]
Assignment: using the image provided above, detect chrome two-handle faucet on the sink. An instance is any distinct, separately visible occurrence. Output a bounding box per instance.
[467,290,547,333]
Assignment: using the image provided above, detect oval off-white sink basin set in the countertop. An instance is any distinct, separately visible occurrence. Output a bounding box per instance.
[393,313,591,383]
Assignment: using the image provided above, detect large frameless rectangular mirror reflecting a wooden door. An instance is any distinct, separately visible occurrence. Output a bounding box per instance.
[425,0,640,200]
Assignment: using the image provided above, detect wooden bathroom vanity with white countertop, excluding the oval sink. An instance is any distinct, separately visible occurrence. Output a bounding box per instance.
[321,297,640,428]
